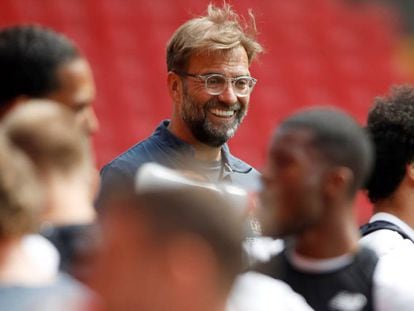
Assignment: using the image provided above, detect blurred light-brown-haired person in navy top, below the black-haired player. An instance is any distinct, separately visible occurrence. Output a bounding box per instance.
[2,100,95,280]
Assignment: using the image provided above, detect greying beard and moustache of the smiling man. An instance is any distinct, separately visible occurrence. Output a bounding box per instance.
[181,87,247,147]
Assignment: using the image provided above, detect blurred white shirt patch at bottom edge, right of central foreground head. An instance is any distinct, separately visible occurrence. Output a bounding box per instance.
[226,272,313,311]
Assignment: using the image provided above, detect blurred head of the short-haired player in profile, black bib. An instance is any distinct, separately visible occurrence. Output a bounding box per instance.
[260,108,372,236]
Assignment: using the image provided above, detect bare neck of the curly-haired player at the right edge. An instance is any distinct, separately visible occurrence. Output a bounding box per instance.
[374,184,414,229]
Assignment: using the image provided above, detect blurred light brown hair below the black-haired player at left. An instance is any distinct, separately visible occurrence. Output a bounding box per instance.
[3,100,91,175]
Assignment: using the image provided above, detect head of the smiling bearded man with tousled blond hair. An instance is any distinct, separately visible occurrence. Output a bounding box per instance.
[167,4,262,147]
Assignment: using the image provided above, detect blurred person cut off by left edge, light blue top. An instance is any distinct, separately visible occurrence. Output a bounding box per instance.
[0,131,89,311]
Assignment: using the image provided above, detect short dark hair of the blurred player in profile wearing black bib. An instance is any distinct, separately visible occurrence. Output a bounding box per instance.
[280,108,373,196]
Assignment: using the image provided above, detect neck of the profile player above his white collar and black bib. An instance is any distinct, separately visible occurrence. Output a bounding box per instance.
[294,202,359,259]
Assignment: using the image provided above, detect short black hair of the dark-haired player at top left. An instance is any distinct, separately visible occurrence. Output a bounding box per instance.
[0,25,80,109]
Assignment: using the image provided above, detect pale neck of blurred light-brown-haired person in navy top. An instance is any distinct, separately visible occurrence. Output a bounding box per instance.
[42,174,95,225]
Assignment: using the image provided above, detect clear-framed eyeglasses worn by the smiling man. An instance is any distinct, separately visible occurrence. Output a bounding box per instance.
[175,72,257,97]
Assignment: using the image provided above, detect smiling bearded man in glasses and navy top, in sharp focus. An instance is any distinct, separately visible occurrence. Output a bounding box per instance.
[101,4,262,196]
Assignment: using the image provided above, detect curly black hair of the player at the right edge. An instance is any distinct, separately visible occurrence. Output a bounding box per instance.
[367,85,414,203]
